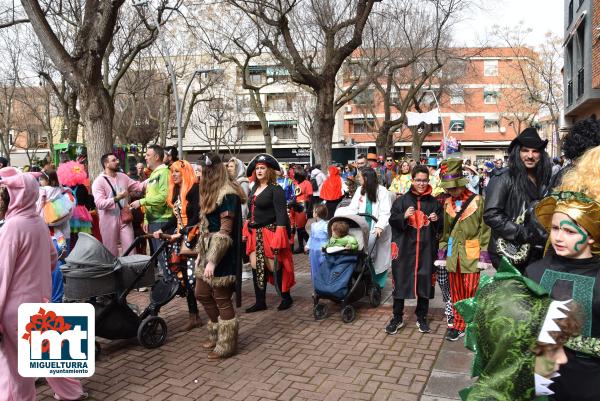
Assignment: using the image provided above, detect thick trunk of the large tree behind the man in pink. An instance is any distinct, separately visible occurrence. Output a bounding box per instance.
[79,82,114,180]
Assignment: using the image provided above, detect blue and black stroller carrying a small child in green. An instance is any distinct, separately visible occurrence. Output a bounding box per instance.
[312,213,381,323]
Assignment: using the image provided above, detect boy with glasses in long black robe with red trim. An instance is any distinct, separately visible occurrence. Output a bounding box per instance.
[385,166,444,334]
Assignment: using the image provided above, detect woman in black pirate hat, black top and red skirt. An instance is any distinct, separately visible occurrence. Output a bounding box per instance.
[244,154,295,313]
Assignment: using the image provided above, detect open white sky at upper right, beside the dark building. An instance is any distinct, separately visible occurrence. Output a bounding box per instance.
[455,0,564,46]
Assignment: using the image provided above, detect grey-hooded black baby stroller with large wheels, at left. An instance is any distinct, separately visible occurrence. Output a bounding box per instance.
[61,233,179,352]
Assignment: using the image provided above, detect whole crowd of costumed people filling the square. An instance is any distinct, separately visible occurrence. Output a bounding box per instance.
[0,113,600,401]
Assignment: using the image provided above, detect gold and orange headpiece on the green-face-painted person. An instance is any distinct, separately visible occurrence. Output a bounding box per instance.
[535,191,600,255]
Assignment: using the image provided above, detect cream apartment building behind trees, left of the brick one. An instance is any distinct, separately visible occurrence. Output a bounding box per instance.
[176,55,343,163]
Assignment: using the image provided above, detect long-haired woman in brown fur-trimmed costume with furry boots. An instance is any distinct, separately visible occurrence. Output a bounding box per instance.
[196,153,246,359]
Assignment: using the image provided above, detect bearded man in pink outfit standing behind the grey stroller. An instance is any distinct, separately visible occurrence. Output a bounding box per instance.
[92,153,144,256]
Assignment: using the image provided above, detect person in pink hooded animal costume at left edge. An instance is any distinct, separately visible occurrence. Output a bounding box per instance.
[0,167,87,401]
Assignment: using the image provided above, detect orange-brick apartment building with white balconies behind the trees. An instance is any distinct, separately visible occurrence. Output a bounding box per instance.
[343,48,539,160]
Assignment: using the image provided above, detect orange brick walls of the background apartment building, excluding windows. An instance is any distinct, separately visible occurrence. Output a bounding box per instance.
[344,47,536,157]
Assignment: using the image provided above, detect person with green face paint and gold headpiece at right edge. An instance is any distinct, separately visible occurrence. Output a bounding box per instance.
[526,147,600,401]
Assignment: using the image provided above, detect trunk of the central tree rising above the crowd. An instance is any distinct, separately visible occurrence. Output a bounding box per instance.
[310,84,335,168]
